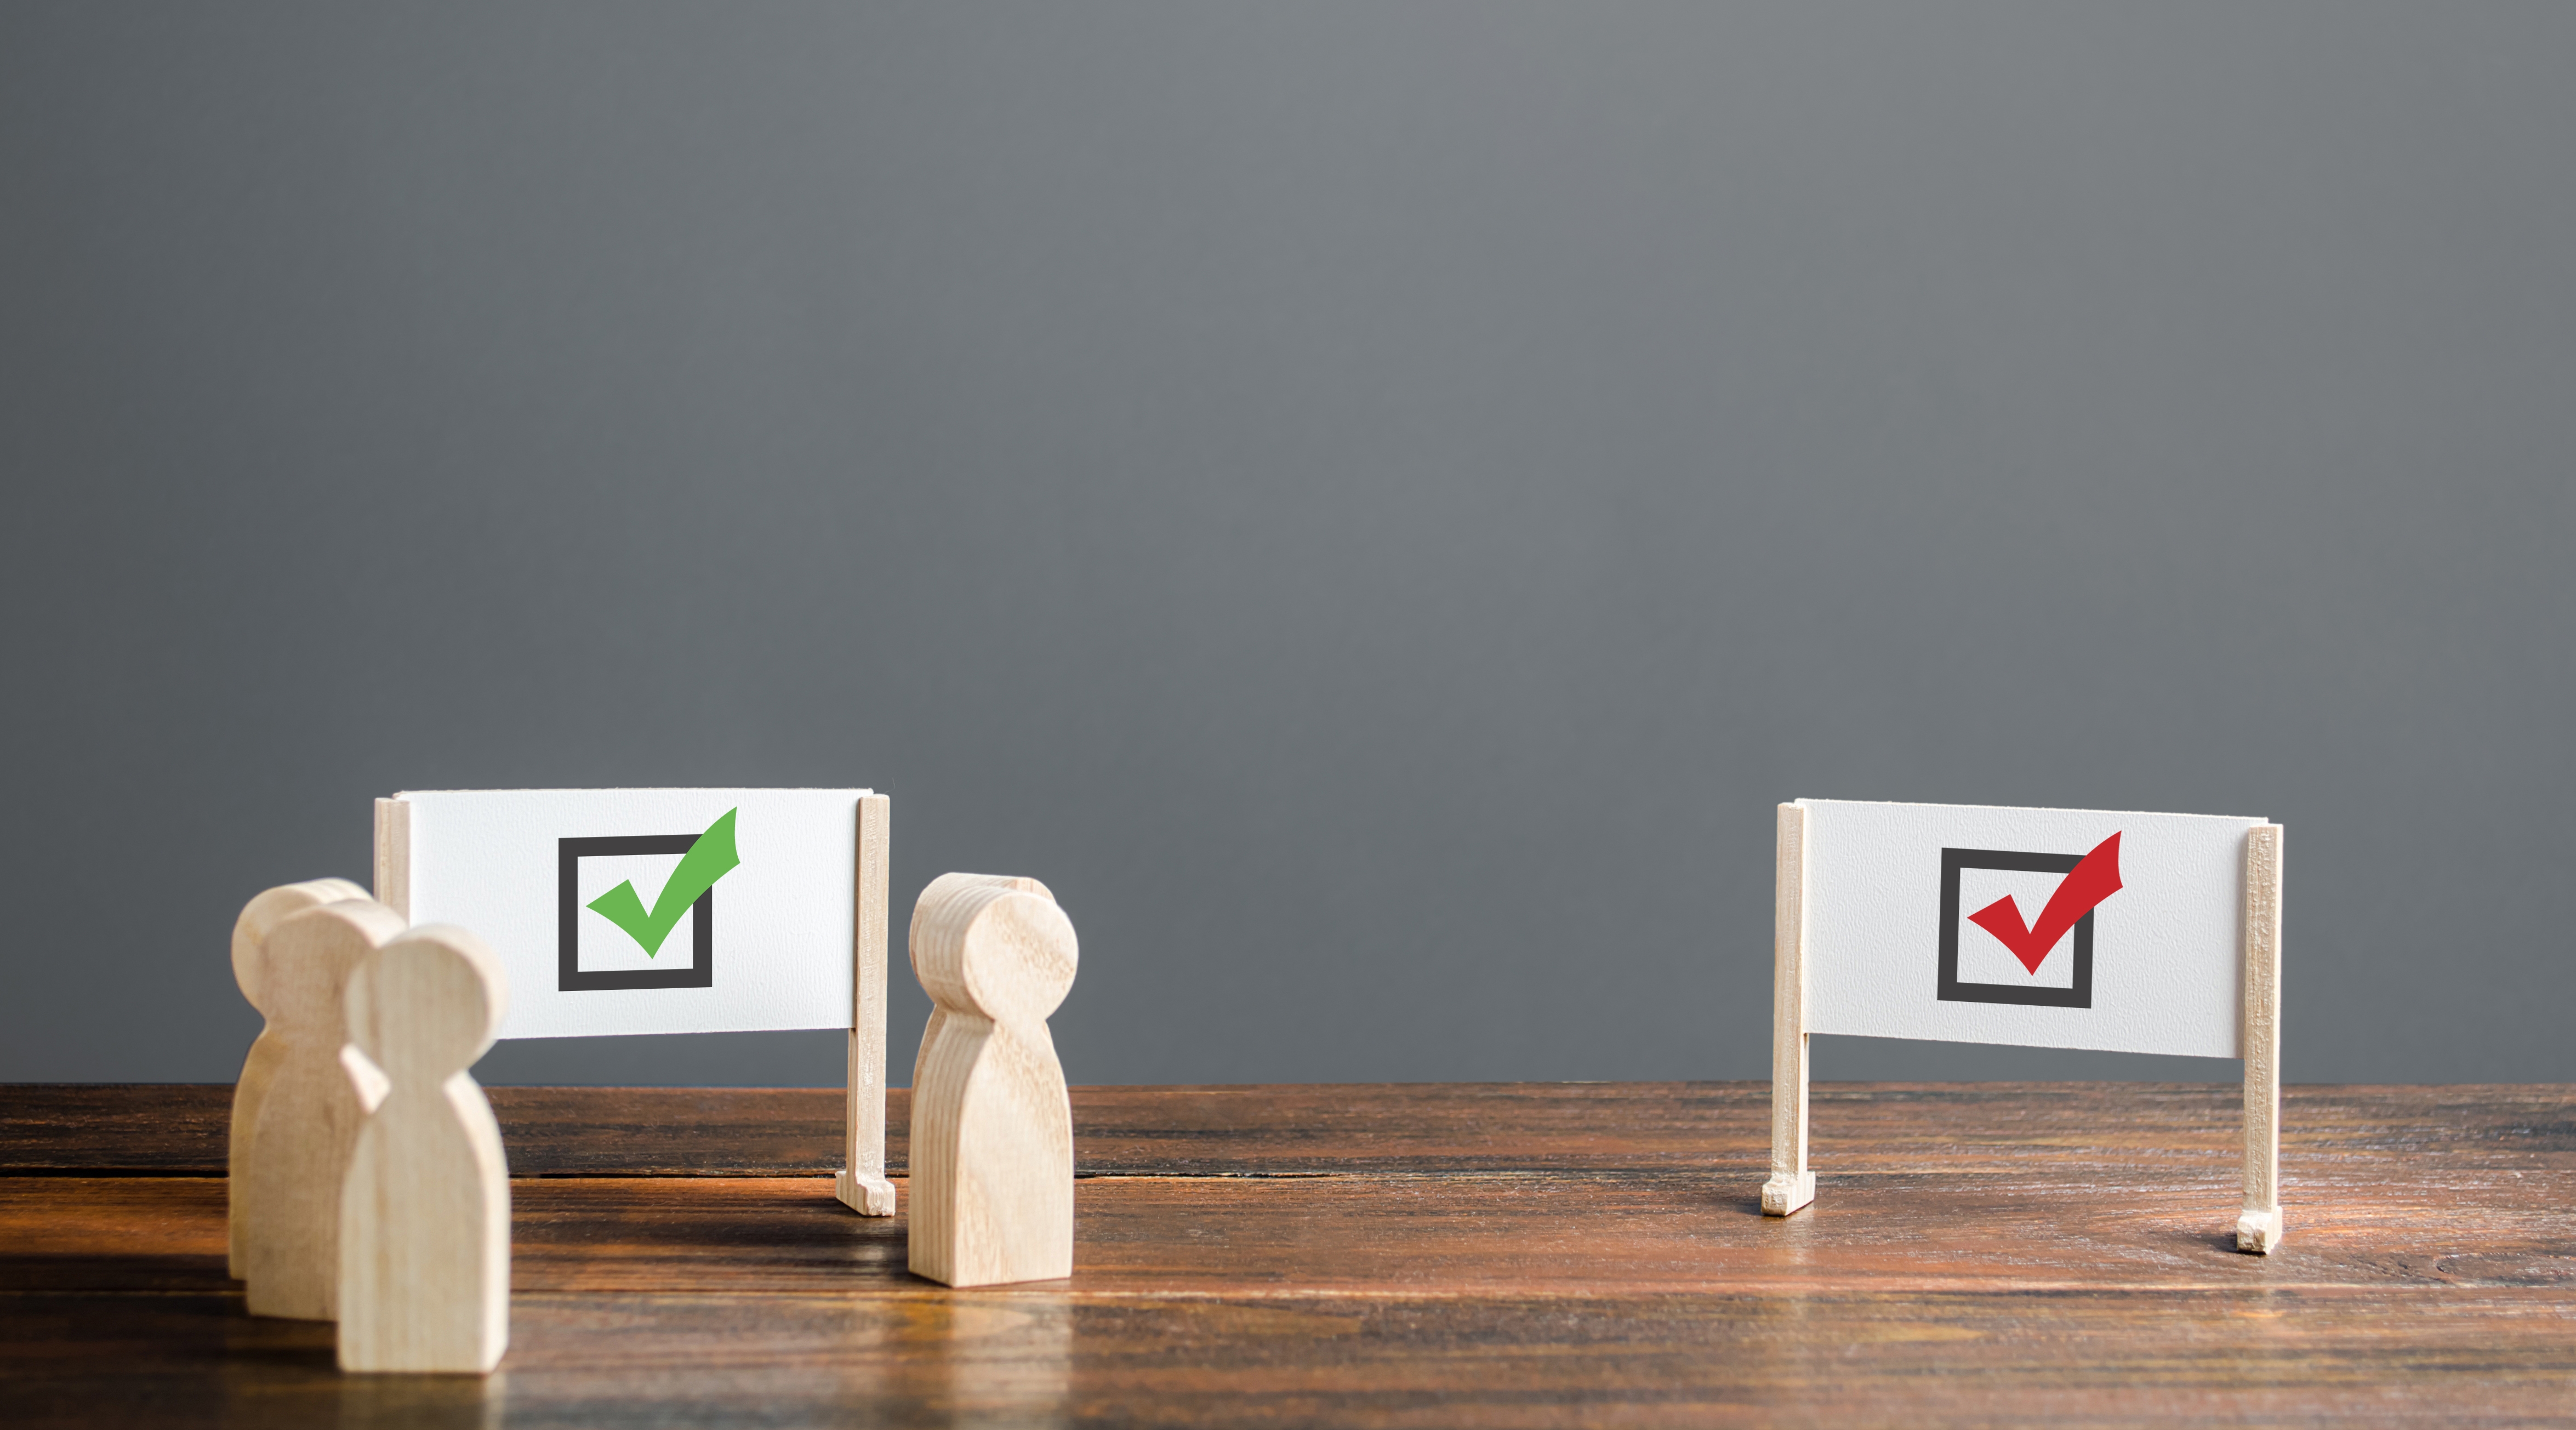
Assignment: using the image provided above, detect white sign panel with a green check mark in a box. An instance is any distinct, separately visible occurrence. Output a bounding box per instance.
[379,788,868,1038]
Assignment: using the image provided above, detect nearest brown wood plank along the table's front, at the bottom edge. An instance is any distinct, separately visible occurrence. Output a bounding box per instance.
[0,1288,2576,1430]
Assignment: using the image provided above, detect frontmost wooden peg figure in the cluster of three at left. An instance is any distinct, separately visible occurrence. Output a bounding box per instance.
[338,925,510,1374]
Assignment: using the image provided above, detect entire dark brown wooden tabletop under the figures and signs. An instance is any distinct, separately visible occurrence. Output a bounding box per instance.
[0,1082,2576,1427]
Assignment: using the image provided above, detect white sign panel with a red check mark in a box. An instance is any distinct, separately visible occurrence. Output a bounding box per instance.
[1798,799,2264,1056]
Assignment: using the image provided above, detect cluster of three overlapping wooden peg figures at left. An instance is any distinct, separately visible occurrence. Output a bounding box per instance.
[227,879,510,1371]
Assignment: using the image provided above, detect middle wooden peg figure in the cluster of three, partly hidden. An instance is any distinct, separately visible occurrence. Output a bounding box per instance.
[232,899,402,1322]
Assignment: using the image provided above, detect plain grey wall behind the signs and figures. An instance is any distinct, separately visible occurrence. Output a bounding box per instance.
[0,0,2576,1082]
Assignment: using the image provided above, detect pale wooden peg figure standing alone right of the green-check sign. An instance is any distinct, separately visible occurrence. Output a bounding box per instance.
[912,874,1077,1286]
